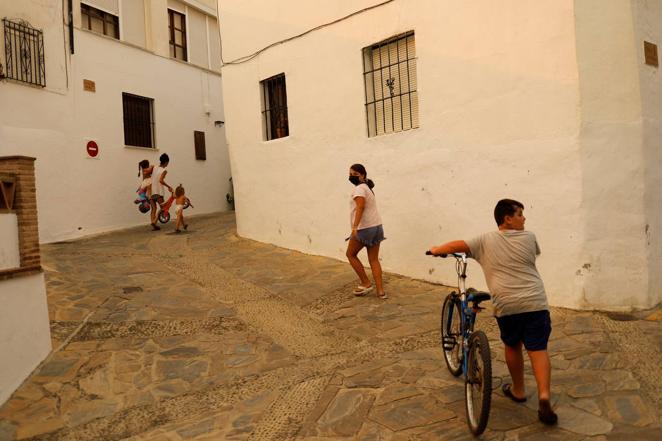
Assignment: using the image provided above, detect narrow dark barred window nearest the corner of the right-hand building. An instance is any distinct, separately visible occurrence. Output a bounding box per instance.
[260,74,290,141]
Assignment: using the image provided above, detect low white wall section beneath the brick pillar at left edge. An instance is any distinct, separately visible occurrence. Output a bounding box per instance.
[0,273,51,404]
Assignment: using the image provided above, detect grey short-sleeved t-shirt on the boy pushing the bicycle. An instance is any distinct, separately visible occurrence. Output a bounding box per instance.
[467,230,548,317]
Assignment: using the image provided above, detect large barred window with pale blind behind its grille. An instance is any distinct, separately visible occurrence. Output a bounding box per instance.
[363,31,418,137]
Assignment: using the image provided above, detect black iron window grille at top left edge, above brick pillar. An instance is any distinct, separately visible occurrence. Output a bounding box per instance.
[2,18,46,87]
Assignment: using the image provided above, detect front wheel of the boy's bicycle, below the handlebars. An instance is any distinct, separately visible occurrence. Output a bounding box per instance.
[441,294,463,377]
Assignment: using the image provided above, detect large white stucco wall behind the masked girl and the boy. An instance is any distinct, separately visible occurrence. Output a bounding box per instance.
[219,0,662,309]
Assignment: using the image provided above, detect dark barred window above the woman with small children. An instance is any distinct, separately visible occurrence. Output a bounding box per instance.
[122,93,154,148]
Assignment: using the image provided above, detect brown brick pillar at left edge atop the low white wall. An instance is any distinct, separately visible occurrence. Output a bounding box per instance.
[0,156,41,269]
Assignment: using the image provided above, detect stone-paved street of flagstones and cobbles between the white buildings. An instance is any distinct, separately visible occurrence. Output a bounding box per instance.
[0,214,662,441]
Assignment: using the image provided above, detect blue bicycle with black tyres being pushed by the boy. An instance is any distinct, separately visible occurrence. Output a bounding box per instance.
[425,251,492,436]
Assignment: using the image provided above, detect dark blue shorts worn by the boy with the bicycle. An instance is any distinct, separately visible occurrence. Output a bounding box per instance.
[497,310,552,351]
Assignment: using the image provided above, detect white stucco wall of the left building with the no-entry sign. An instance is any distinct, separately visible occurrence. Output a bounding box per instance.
[0,0,230,242]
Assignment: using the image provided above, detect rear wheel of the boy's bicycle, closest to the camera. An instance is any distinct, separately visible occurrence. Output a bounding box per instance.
[464,331,492,435]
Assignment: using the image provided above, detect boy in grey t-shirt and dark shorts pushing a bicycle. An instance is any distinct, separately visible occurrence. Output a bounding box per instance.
[430,199,558,424]
